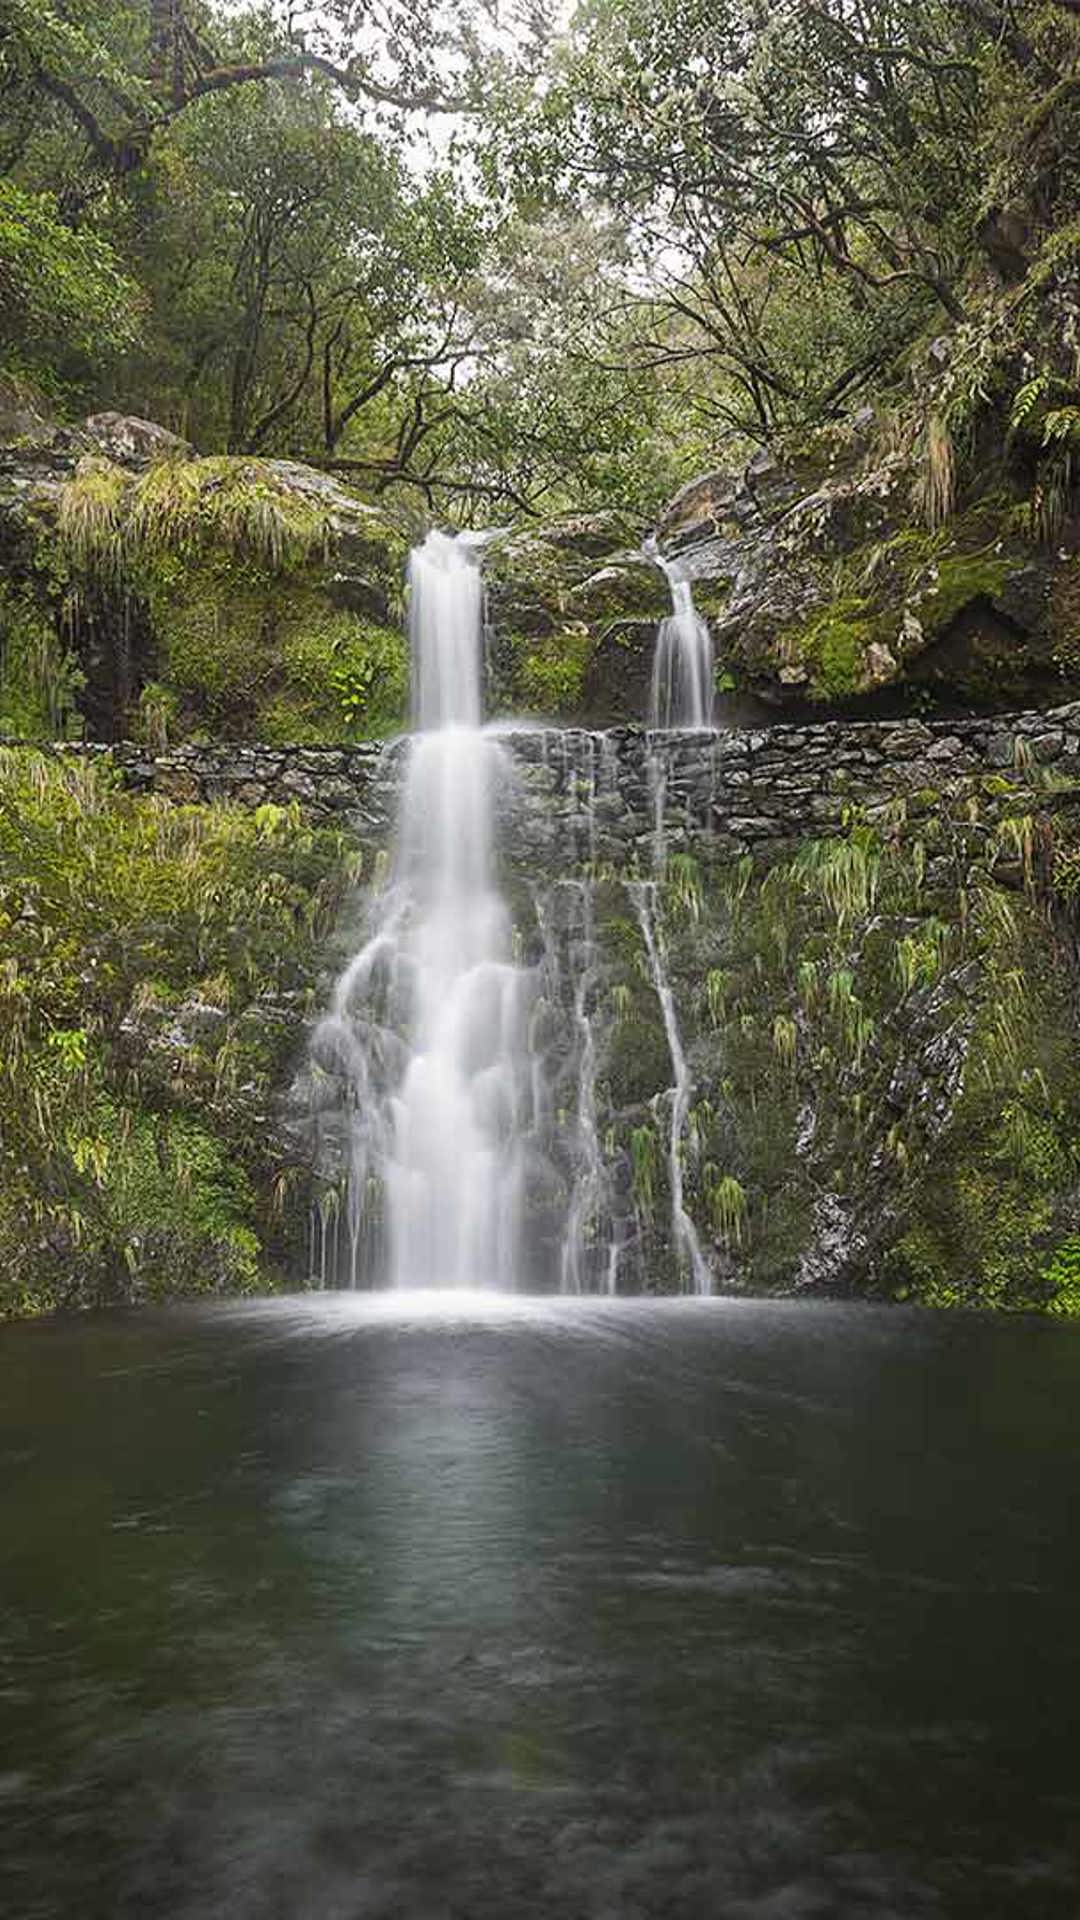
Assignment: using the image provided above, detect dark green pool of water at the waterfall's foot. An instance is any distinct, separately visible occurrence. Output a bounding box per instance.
[0,1296,1080,1920]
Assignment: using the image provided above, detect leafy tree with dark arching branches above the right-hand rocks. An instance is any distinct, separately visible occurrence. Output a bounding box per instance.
[488,0,1076,440]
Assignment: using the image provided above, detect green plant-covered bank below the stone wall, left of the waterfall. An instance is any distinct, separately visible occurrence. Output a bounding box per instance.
[0,751,350,1311]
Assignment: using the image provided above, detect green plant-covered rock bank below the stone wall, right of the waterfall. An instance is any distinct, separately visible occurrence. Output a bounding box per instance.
[645,783,1080,1313]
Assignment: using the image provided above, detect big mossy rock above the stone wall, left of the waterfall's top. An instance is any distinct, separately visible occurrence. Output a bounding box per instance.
[0,430,409,743]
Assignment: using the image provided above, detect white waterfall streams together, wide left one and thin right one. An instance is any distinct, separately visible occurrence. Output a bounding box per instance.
[311,534,713,1292]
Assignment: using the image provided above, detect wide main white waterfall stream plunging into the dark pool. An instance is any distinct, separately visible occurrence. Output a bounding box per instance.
[313,534,532,1288]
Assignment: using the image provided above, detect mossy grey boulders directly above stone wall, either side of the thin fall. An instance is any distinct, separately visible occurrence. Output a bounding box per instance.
[476,409,1080,724]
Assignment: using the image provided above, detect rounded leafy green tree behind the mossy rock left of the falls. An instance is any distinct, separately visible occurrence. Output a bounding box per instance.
[119,84,484,470]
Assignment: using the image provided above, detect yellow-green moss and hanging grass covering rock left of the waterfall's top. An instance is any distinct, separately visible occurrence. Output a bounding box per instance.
[49,457,407,741]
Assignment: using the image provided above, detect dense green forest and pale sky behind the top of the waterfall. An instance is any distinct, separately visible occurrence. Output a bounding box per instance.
[0,0,1080,520]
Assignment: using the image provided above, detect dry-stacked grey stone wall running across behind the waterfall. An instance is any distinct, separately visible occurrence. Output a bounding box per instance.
[18,703,1080,868]
